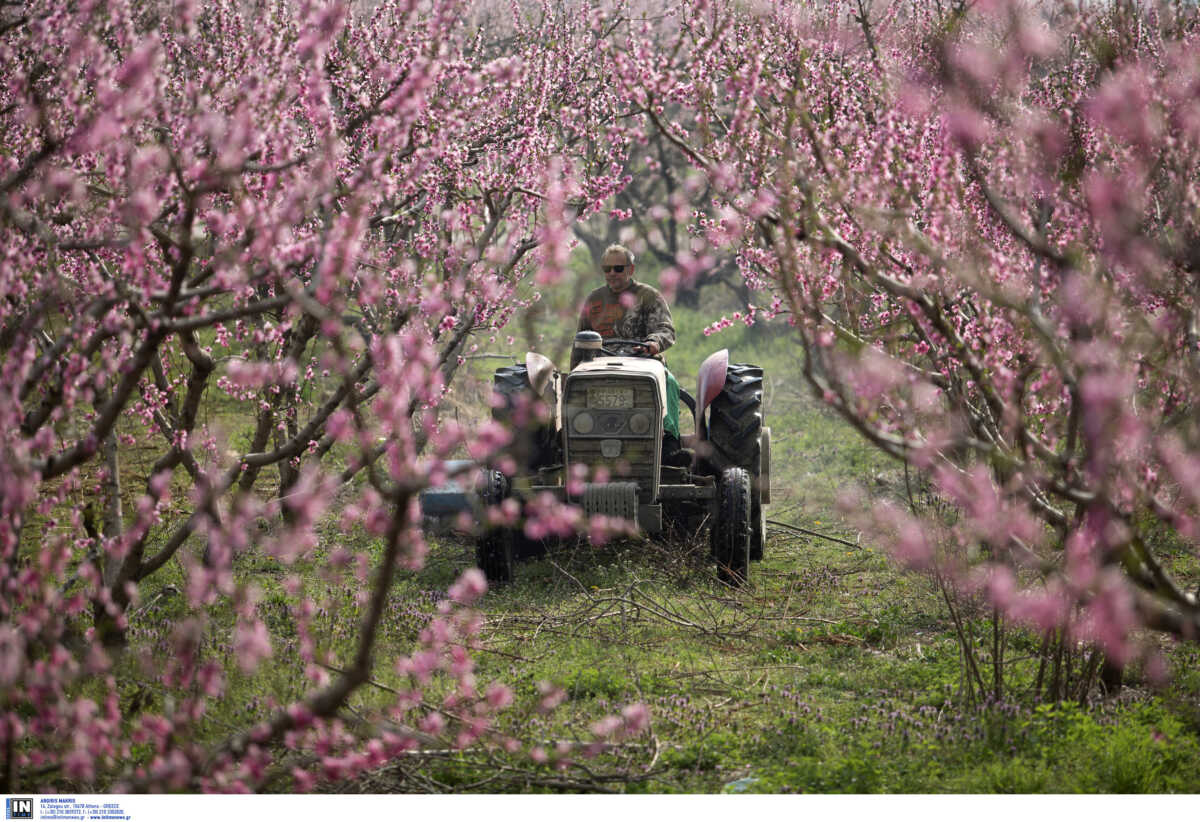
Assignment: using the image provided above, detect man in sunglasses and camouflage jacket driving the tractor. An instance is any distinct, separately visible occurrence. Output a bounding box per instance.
[571,245,691,464]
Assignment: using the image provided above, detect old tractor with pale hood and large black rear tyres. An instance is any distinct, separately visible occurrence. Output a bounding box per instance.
[476,331,770,586]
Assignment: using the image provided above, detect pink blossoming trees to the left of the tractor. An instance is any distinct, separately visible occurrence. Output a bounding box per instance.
[0,0,637,792]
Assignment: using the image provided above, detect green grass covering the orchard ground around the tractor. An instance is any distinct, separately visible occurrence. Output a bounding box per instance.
[37,253,1200,793]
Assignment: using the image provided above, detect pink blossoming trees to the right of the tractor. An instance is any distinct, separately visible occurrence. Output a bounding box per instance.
[626,1,1200,689]
